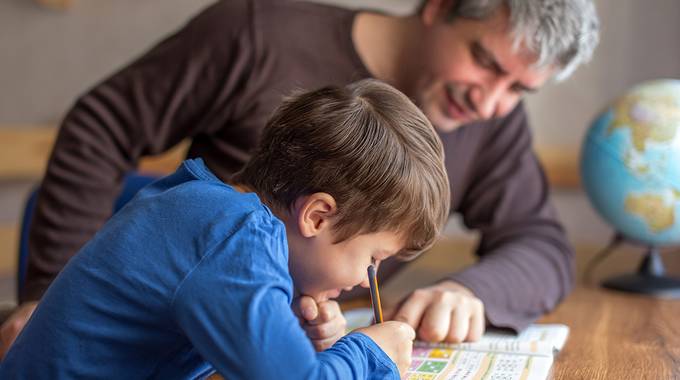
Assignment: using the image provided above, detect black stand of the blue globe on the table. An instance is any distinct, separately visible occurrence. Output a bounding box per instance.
[602,237,680,298]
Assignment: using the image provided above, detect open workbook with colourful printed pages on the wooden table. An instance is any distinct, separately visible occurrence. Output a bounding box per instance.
[345,309,569,380]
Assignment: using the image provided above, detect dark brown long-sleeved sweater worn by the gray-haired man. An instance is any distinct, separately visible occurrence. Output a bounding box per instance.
[22,0,573,329]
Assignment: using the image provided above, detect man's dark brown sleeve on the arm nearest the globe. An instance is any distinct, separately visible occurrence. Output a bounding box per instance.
[450,104,574,330]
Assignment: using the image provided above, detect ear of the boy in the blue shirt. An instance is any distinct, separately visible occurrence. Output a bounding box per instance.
[297,193,337,238]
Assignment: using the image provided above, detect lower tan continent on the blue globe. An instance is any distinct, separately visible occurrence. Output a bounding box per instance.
[625,191,680,233]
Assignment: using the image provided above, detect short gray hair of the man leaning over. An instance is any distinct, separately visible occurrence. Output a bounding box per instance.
[448,0,600,81]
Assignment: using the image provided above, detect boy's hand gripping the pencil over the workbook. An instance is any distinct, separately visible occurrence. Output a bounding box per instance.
[354,321,416,377]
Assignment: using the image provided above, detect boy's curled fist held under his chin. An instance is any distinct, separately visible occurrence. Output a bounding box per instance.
[293,296,347,352]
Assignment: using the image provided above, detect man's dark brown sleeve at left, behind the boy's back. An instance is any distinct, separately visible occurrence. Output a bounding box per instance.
[21,1,253,302]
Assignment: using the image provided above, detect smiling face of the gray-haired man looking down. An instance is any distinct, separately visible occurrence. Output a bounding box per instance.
[413,2,554,131]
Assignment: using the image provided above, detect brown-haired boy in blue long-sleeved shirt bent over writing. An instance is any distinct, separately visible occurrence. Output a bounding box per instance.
[0,80,450,379]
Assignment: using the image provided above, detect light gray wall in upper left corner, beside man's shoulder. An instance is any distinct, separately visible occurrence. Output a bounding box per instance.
[0,0,212,121]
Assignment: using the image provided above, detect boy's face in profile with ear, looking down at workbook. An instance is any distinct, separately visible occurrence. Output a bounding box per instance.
[283,194,404,302]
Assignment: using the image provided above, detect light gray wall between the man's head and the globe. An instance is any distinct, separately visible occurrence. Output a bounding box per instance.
[528,0,680,146]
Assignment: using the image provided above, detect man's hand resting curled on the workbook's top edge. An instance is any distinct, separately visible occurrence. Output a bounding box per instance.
[391,281,485,343]
